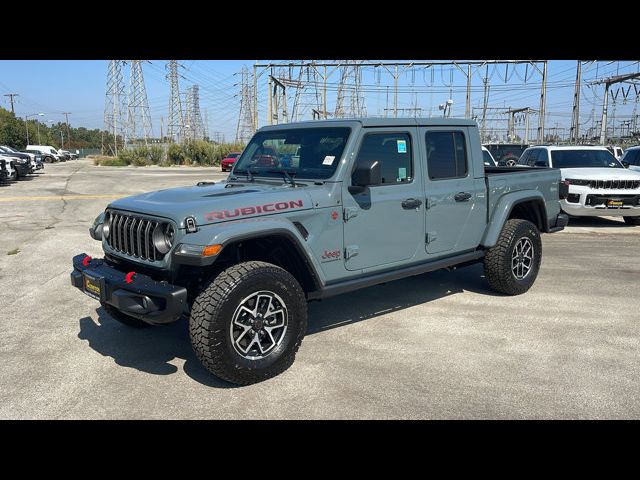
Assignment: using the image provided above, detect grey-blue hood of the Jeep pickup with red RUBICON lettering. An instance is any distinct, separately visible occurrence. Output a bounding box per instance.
[109,182,313,228]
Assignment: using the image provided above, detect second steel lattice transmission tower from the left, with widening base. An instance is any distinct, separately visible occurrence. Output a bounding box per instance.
[125,60,151,145]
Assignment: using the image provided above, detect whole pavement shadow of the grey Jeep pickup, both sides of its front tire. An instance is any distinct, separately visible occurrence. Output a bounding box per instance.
[78,265,499,388]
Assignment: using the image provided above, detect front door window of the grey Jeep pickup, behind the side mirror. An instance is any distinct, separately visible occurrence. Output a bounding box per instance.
[356,133,413,185]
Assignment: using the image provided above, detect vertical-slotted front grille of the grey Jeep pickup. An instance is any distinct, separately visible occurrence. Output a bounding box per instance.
[107,210,170,262]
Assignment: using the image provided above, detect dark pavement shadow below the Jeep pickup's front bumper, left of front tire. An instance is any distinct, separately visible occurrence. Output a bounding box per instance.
[78,307,237,388]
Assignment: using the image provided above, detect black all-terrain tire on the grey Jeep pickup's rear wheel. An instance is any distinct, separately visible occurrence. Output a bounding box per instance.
[484,219,542,295]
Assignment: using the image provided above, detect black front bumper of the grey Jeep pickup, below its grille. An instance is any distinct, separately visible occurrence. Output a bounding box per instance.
[71,253,187,325]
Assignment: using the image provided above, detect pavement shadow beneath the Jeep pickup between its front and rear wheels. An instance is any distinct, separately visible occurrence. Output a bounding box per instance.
[307,264,502,335]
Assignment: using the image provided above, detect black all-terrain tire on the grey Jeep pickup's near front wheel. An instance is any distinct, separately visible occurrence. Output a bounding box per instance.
[189,261,307,385]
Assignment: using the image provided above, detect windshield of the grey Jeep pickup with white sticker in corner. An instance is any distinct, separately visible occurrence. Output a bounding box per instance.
[233,127,350,179]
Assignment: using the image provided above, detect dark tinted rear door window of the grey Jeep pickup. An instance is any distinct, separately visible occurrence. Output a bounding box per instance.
[426,132,467,180]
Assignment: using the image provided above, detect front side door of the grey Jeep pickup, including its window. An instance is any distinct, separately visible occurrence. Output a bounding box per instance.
[343,127,424,270]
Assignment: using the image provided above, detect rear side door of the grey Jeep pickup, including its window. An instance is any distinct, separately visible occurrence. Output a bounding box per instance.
[419,127,486,254]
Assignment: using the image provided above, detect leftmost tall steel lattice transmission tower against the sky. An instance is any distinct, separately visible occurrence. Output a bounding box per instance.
[102,60,126,155]
